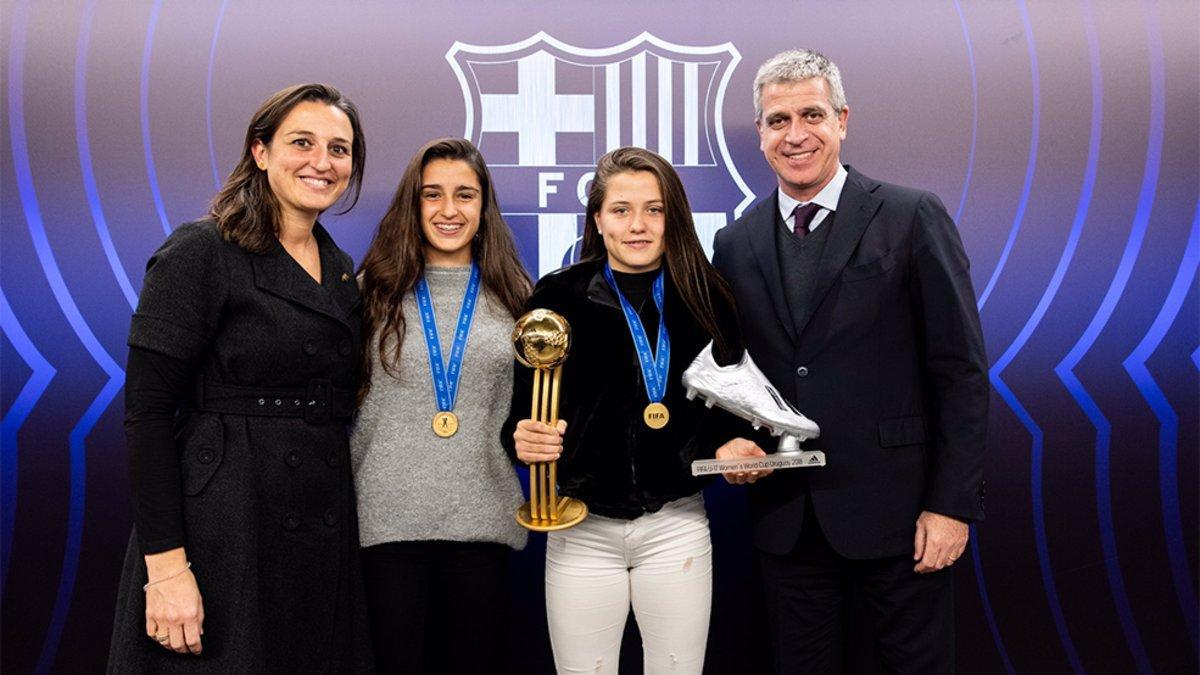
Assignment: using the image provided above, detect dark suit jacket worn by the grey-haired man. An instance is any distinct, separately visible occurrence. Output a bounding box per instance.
[713,167,989,558]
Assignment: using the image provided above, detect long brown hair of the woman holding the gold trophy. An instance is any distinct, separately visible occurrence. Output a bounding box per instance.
[580,148,733,356]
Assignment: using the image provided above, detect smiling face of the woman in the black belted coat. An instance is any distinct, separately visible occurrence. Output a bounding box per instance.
[252,101,354,227]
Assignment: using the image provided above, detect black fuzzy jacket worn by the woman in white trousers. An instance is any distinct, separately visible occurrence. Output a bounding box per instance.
[500,255,745,519]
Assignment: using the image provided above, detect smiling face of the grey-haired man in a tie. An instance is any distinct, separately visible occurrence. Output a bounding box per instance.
[755,77,850,202]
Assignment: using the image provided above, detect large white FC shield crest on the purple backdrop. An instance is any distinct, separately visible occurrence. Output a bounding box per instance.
[446,32,754,276]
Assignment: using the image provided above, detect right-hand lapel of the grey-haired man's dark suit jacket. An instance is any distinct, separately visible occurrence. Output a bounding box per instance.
[797,167,883,333]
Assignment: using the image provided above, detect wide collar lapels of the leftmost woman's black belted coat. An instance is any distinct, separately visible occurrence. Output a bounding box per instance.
[254,225,356,327]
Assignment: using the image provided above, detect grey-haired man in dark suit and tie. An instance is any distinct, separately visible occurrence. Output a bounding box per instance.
[713,52,988,673]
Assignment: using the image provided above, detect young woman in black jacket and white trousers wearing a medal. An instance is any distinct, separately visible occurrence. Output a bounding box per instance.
[504,148,749,673]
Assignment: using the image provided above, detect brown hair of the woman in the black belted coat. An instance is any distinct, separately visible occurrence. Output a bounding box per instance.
[209,84,367,253]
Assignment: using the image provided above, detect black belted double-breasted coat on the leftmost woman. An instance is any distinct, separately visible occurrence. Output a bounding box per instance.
[109,221,370,673]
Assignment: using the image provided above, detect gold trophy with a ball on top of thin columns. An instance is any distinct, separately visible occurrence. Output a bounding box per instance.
[512,310,588,532]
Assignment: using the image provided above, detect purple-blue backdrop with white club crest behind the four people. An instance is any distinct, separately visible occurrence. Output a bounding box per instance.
[0,0,1200,673]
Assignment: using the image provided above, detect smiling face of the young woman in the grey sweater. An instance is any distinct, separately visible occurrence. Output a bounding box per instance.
[420,159,484,267]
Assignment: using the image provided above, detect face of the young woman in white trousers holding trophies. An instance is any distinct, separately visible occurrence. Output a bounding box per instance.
[595,171,666,273]
